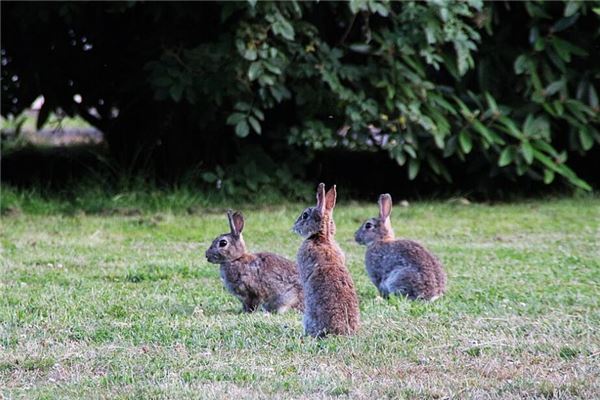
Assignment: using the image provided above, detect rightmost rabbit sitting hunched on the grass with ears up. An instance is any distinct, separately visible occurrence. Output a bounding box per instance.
[354,193,446,301]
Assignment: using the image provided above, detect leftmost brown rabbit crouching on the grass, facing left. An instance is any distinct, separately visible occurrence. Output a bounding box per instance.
[206,210,304,313]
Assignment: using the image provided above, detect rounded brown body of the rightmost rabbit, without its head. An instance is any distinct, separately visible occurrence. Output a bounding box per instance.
[365,240,446,300]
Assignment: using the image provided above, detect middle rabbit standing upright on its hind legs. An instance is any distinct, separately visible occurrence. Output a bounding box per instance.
[292,183,360,338]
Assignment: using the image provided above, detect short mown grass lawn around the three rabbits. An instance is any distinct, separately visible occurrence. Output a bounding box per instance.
[0,193,600,399]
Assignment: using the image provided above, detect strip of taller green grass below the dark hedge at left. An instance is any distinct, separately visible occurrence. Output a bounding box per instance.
[0,184,314,216]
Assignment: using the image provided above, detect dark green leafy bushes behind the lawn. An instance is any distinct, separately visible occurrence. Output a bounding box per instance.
[2,0,600,193]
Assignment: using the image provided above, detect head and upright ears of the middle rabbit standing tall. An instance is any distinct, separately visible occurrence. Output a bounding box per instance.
[292,183,337,238]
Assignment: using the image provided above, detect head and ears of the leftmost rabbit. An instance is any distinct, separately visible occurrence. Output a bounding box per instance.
[206,210,246,264]
